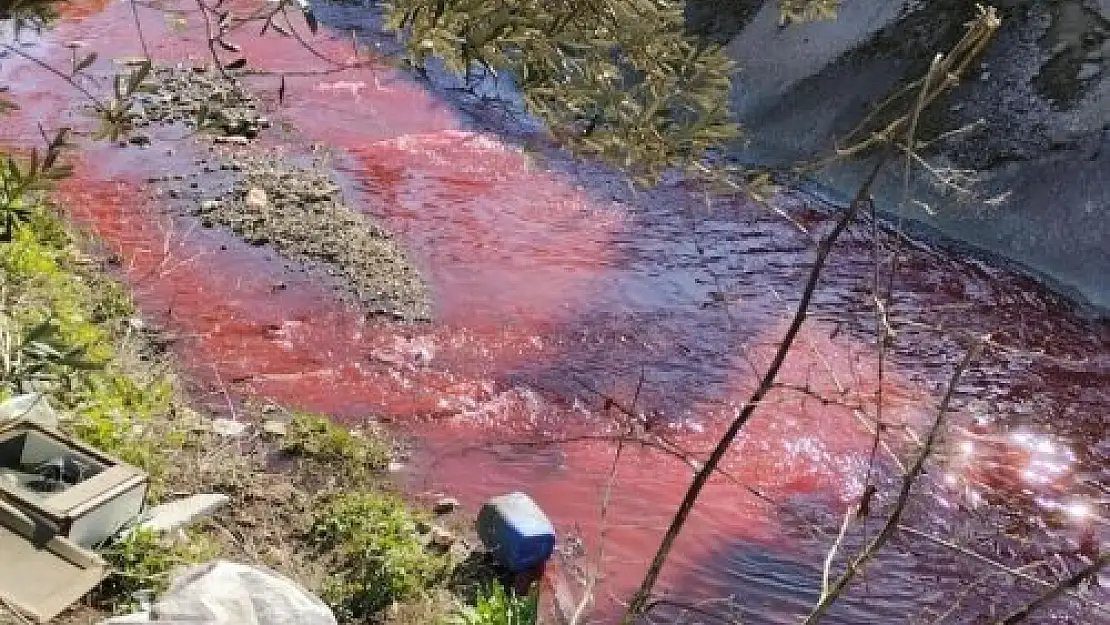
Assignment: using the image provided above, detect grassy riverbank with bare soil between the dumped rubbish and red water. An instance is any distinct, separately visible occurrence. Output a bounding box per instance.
[0,169,483,625]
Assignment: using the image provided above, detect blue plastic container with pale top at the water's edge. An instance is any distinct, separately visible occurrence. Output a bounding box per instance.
[477,493,555,573]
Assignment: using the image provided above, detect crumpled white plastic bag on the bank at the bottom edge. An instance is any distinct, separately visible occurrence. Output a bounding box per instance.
[100,561,336,625]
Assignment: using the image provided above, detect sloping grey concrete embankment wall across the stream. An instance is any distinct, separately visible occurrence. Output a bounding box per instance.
[728,0,1110,312]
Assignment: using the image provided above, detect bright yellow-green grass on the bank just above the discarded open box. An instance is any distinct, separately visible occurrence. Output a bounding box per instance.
[0,204,183,494]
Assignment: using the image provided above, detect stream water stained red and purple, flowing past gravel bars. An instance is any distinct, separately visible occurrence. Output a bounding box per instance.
[0,2,1110,624]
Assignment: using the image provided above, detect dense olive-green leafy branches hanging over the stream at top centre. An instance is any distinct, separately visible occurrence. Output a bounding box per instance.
[389,0,738,182]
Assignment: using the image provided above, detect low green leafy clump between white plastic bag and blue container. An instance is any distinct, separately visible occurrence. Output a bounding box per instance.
[311,493,448,621]
